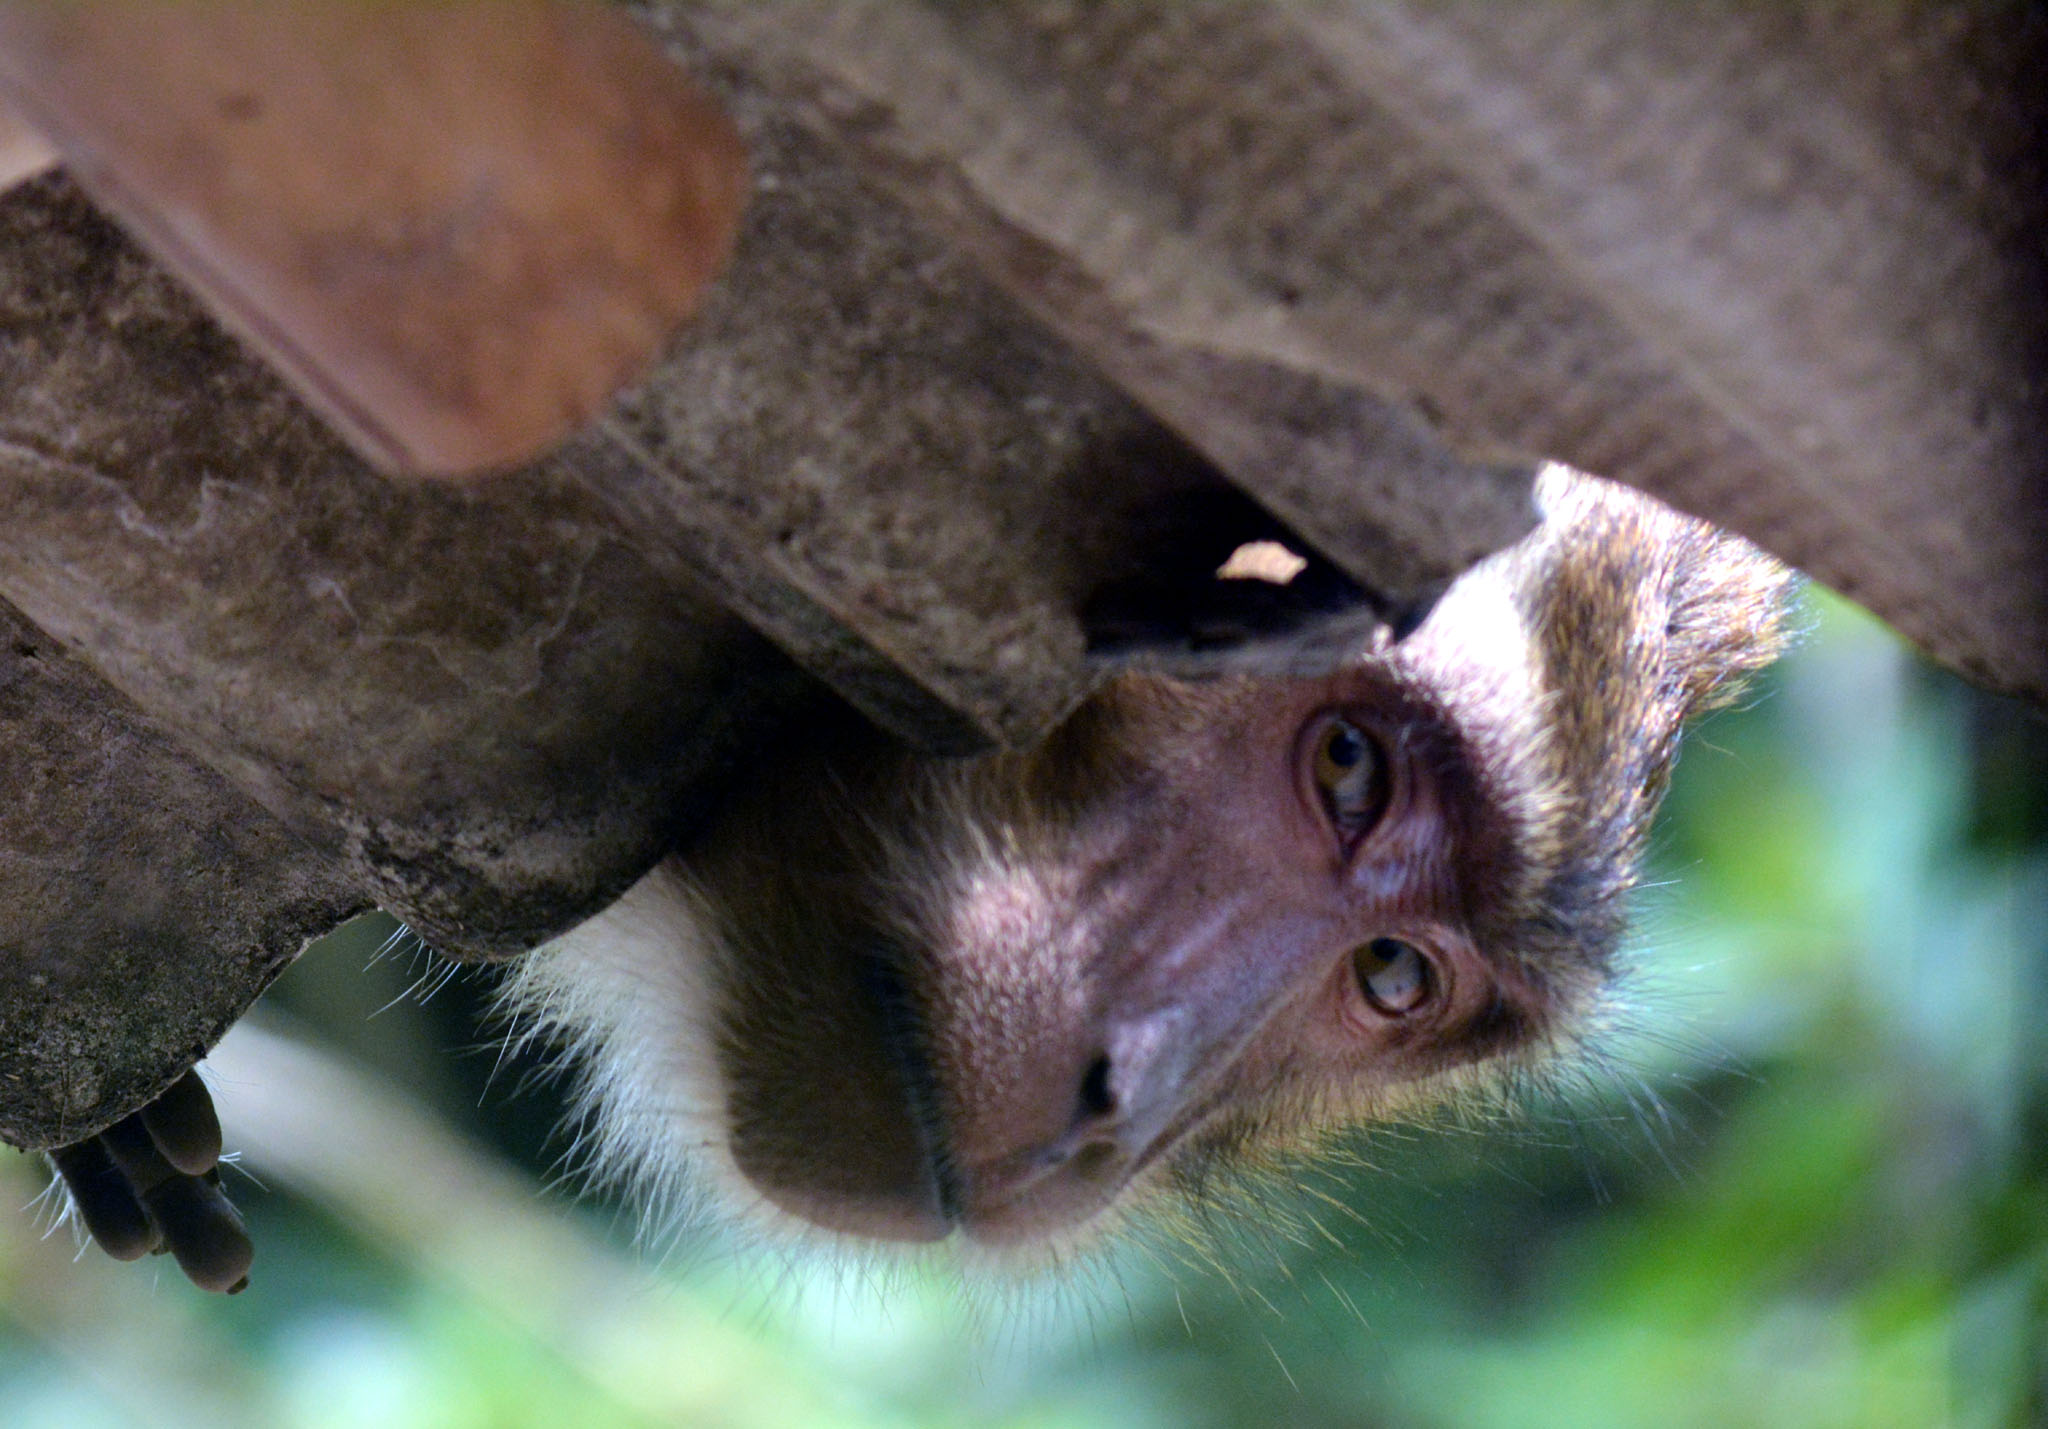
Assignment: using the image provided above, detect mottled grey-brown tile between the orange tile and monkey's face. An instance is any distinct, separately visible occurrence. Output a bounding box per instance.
[565,121,1335,749]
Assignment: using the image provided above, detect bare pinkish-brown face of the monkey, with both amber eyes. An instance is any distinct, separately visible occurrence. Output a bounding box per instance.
[692,593,1554,1247]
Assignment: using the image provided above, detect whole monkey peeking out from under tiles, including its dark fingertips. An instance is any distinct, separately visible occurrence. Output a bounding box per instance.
[48,465,1796,1288]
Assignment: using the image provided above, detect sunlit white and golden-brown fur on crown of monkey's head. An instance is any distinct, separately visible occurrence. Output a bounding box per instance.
[1438,465,1796,995]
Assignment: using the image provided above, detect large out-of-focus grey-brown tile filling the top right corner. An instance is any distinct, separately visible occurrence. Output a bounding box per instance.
[692,0,2048,698]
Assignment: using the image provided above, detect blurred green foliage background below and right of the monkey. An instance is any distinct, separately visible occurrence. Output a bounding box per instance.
[0,596,2048,1429]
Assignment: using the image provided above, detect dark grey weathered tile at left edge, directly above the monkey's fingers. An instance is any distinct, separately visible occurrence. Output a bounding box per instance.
[0,589,369,1146]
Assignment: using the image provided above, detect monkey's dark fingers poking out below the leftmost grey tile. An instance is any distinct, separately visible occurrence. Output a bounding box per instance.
[49,1071,256,1294]
